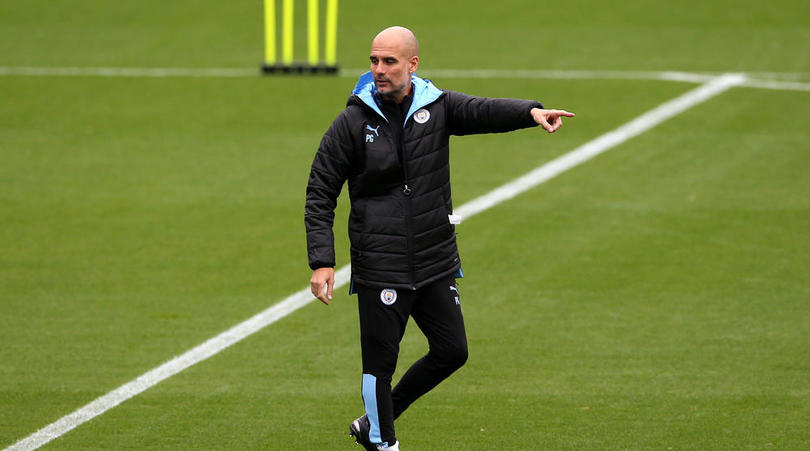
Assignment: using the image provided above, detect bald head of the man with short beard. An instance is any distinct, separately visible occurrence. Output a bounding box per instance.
[370,27,419,103]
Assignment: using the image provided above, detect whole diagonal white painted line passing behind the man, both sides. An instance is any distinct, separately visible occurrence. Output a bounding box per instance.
[1,74,745,451]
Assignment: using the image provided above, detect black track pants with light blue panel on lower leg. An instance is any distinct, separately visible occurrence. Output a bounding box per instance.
[356,276,467,445]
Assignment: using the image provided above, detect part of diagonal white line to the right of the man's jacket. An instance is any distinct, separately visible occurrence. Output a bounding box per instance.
[453,74,746,219]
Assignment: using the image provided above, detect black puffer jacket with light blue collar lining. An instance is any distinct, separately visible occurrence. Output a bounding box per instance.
[305,73,542,289]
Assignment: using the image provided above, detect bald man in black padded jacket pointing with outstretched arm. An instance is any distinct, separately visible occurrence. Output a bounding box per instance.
[305,27,573,451]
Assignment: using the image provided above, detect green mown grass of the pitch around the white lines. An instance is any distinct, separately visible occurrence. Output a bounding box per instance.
[0,0,810,451]
